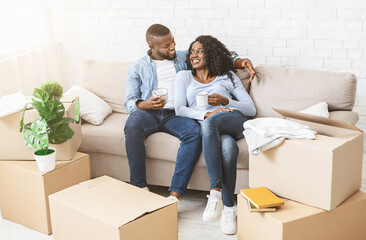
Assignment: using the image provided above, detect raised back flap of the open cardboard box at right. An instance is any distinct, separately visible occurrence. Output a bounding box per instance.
[272,108,362,132]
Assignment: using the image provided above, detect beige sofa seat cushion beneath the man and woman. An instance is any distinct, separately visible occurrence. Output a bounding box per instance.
[79,112,248,169]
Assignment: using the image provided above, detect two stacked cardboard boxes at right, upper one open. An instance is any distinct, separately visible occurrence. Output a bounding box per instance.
[238,110,366,240]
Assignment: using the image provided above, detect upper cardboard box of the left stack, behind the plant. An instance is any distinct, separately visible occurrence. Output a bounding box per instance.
[0,96,82,161]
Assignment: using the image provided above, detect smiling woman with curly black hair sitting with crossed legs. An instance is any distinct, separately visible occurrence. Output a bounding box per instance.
[174,36,256,234]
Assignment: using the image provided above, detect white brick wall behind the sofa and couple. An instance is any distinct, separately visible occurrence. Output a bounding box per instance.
[48,0,366,150]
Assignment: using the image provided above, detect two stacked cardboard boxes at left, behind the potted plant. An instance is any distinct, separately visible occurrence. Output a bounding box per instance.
[0,98,90,234]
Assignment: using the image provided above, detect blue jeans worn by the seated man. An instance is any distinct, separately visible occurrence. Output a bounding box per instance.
[125,109,202,195]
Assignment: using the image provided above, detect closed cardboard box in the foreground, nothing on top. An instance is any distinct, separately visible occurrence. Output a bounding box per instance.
[49,176,178,240]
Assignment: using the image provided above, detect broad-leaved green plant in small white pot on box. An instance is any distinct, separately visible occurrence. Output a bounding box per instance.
[20,88,80,172]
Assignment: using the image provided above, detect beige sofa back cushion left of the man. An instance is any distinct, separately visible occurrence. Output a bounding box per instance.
[80,60,131,113]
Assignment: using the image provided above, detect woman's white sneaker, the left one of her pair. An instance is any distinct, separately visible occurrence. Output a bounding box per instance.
[202,190,223,222]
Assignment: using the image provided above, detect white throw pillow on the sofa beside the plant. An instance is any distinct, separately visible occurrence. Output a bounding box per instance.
[64,85,112,125]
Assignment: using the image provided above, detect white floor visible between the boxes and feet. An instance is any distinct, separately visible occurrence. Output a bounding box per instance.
[0,153,366,240]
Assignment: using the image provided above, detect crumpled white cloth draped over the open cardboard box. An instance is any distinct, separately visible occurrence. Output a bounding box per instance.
[243,117,316,155]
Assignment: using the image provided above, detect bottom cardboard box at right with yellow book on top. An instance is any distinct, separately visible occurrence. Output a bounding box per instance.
[238,191,366,240]
